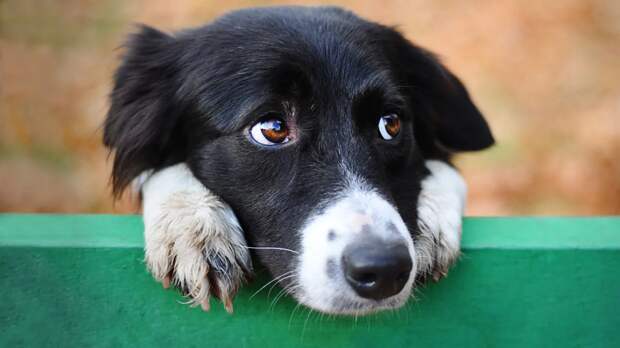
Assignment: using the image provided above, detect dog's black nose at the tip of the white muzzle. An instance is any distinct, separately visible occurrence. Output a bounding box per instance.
[342,240,412,300]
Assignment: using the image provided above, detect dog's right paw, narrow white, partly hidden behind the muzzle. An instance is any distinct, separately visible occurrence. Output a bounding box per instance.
[414,160,467,281]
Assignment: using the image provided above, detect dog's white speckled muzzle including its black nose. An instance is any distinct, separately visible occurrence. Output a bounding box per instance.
[285,188,417,315]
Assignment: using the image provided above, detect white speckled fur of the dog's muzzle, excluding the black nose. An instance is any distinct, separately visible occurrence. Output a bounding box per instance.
[293,184,416,314]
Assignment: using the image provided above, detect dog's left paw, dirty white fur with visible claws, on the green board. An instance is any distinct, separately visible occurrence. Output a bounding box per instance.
[137,164,252,312]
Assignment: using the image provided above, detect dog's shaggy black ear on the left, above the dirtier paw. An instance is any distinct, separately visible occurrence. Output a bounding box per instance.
[103,26,180,196]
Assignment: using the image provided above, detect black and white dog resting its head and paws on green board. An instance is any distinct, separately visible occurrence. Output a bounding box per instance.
[104,7,494,315]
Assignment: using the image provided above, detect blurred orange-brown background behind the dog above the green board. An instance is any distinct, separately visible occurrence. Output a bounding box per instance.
[0,0,620,215]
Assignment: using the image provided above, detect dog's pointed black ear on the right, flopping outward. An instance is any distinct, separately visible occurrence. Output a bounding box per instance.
[390,35,495,152]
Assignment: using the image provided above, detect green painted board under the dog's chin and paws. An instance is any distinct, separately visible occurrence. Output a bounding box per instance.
[0,215,620,347]
